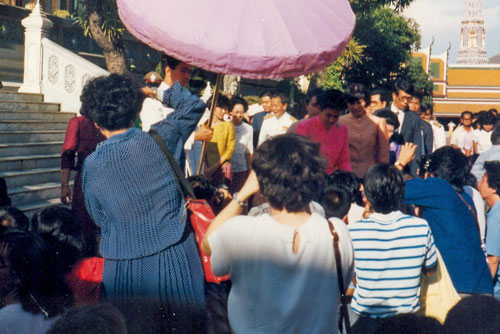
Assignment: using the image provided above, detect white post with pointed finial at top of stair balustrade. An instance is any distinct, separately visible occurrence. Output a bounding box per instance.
[19,1,54,94]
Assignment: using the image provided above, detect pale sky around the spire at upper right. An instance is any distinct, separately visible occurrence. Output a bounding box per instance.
[403,0,500,64]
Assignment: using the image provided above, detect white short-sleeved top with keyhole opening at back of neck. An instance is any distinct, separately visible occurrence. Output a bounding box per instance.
[208,213,353,334]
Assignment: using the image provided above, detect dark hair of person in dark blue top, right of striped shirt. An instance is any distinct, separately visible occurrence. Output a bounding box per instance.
[428,146,469,192]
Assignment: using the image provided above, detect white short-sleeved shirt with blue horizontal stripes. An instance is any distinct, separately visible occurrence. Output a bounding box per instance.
[349,211,437,318]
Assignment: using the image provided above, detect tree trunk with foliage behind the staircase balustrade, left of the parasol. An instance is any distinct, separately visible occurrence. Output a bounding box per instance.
[74,0,128,74]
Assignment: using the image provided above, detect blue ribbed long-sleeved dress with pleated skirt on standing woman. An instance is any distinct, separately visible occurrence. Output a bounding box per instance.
[82,83,205,333]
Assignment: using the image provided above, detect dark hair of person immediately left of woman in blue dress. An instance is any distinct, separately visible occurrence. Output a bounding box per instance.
[30,205,85,267]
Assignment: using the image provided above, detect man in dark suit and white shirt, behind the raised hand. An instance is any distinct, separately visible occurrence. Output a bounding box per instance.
[391,80,422,176]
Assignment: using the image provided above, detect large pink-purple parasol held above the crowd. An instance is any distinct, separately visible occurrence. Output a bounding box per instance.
[117,0,355,79]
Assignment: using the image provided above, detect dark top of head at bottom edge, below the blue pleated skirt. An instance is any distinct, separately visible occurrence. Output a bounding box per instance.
[46,304,127,334]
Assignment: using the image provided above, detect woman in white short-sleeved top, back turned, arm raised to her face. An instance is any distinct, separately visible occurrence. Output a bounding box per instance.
[202,134,353,333]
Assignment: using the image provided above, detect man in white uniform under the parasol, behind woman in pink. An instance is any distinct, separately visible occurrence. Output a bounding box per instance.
[258,92,297,145]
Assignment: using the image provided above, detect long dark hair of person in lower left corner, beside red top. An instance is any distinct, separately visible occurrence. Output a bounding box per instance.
[4,231,73,318]
